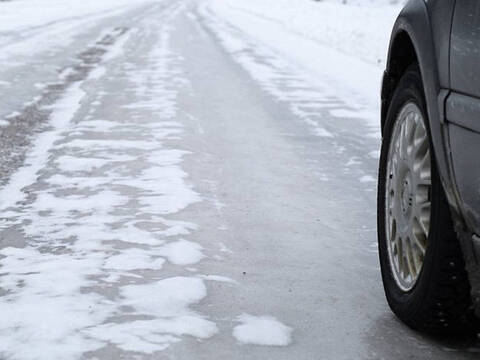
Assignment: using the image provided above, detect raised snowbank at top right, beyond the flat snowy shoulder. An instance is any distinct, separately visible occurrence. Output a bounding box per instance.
[212,0,401,66]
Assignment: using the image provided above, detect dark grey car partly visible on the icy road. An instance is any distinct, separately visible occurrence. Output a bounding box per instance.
[377,0,480,334]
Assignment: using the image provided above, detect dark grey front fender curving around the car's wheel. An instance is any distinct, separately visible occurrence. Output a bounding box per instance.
[381,0,459,217]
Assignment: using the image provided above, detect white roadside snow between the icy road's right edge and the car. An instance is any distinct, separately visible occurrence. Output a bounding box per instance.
[204,0,401,129]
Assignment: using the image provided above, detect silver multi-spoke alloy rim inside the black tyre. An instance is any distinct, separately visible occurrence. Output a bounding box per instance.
[385,102,432,291]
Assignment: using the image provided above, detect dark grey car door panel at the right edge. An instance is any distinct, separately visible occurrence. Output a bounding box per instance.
[445,0,480,233]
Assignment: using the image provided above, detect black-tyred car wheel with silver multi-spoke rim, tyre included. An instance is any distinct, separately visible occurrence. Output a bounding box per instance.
[377,65,474,333]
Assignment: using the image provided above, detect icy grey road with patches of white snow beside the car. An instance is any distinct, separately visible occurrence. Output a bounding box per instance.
[0,0,480,360]
